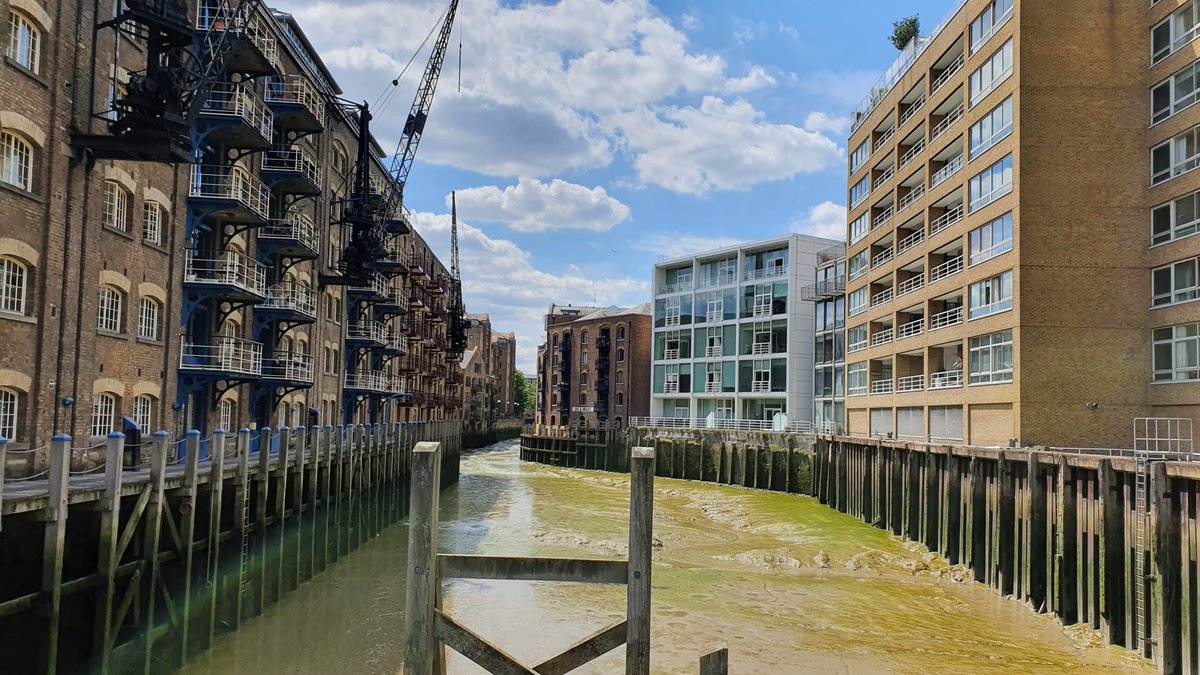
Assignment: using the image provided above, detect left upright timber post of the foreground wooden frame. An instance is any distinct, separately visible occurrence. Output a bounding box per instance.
[404,441,442,674]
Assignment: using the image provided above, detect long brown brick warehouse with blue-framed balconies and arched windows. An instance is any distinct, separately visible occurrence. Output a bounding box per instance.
[0,0,461,448]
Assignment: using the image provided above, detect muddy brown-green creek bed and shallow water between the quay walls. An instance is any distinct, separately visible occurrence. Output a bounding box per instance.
[184,441,1154,675]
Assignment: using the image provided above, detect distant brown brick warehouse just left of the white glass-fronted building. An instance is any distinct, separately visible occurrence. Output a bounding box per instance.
[538,303,654,428]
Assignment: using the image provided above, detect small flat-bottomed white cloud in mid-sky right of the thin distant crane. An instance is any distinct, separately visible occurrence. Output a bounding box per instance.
[457,178,630,232]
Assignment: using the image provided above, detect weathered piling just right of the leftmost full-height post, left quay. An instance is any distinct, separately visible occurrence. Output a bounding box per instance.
[91,432,125,674]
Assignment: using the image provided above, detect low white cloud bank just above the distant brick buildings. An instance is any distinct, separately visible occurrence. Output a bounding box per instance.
[413,213,649,372]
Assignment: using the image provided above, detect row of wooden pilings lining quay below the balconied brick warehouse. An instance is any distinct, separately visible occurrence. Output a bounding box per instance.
[0,422,461,673]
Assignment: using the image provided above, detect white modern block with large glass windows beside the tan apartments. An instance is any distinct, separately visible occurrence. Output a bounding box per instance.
[650,234,839,422]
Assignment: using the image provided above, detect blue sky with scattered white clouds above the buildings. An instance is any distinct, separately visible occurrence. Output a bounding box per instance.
[290,0,950,372]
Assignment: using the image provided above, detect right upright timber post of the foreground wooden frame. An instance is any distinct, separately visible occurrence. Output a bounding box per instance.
[625,447,654,675]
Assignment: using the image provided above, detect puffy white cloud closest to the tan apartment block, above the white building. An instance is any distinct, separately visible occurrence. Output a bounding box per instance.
[609,96,842,195]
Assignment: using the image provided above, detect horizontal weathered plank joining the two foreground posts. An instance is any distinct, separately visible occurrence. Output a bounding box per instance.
[438,554,629,584]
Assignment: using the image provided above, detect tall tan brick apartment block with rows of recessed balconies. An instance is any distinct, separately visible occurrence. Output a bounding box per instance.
[846,0,1200,447]
